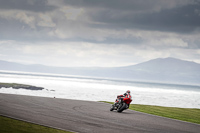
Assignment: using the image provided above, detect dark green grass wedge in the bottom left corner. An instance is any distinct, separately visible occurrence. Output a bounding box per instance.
[0,116,71,133]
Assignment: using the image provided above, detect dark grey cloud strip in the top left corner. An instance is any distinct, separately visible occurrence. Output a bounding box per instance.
[0,0,56,12]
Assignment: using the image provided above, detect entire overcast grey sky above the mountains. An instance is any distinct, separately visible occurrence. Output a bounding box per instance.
[0,0,200,67]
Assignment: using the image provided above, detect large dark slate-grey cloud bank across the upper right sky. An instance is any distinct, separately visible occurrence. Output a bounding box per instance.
[81,2,200,33]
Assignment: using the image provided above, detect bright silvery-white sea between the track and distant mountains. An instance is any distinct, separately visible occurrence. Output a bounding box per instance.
[0,71,200,108]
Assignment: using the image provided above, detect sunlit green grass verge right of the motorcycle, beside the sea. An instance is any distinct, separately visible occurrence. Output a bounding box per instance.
[102,102,200,124]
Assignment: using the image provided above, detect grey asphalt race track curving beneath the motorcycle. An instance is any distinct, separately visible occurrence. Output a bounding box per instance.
[0,94,200,133]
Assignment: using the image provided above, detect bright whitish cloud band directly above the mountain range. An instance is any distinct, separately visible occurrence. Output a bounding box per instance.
[0,40,200,67]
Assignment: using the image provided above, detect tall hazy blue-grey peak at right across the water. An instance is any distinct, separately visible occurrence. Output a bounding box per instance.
[119,58,200,84]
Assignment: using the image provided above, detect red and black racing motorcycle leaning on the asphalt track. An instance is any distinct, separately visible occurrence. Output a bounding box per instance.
[110,95,132,113]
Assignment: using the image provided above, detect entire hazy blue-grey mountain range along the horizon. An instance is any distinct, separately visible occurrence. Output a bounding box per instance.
[0,58,200,85]
